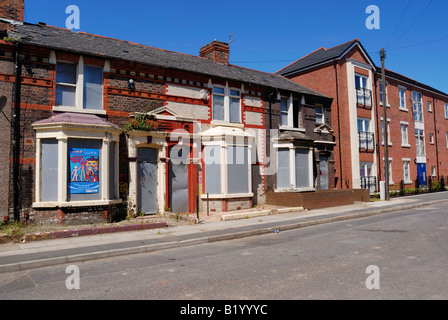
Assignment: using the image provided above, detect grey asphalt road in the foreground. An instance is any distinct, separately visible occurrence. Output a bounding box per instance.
[0,205,448,301]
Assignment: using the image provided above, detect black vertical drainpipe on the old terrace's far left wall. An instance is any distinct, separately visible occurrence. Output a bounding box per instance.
[12,42,22,221]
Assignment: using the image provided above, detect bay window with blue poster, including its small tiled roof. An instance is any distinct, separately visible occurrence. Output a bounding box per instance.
[33,113,121,208]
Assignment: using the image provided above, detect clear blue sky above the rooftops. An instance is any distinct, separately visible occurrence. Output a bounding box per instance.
[25,0,448,93]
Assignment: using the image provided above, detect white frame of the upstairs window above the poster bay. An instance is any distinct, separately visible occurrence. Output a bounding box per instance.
[53,56,109,115]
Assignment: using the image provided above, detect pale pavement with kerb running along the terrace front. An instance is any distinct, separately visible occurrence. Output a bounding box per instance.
[0,191,448,273]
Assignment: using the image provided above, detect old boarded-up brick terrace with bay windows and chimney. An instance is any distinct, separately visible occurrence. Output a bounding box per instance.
[0,0,334,222]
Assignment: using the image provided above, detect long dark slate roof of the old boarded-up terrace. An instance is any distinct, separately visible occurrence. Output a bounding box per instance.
[10,23,328,98]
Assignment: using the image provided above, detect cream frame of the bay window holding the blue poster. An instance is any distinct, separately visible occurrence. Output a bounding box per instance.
[33,123,122,208]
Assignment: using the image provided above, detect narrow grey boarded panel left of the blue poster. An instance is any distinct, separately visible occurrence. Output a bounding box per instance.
[40,139,59,201]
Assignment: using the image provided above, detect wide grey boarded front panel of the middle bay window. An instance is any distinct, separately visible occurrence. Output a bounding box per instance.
[227,146,249,193]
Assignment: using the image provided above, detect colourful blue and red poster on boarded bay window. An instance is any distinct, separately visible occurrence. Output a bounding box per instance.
[69,148,100,194]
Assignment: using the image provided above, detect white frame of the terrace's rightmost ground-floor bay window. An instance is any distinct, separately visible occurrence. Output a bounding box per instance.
[274,143,315,192]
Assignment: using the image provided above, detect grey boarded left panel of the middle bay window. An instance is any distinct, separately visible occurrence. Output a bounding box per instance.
[204,146,221,194]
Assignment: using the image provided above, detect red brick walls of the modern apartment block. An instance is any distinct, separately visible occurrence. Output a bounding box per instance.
[287,38,448,190]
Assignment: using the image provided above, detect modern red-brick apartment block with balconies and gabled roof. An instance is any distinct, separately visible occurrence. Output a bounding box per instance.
[277,39,448,192]
